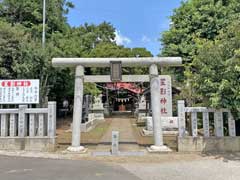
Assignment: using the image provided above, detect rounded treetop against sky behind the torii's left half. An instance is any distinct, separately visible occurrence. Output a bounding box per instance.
[49,22,115,57]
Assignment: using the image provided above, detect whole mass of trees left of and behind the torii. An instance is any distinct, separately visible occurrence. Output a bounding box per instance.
[0,0,152,104]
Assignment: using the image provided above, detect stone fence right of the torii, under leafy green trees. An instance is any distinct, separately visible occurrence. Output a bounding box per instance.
[178,101,240,151]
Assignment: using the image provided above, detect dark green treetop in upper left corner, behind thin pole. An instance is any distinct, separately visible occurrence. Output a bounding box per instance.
[0,0,74,38]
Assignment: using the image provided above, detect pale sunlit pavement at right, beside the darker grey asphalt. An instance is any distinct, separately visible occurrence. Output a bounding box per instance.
[122,159,240,180]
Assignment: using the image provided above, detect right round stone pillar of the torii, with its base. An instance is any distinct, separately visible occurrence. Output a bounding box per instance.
[149,64,169,151]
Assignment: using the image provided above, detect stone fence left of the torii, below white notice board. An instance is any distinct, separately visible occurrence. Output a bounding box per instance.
[0,102,56,151]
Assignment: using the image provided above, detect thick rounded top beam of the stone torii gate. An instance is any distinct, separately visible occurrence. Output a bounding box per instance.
[52,57,182,67]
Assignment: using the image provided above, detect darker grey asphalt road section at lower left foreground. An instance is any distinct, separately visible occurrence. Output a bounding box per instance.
[0,156,140,180]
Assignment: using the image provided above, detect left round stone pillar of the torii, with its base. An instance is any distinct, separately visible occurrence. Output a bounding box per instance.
[68,65,85,152]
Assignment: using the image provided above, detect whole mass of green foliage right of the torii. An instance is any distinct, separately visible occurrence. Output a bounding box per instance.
[160,0,240,117]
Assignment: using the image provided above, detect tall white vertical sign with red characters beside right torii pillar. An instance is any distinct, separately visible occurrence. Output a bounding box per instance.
[159,75,172,117]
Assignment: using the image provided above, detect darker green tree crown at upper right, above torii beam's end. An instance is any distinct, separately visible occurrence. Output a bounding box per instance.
[161,0,240,63]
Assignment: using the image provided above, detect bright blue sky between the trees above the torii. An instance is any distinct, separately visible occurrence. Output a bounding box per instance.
[68,0,181,55]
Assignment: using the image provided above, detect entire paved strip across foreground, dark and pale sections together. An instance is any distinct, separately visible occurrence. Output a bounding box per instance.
[0,156,240,180]
